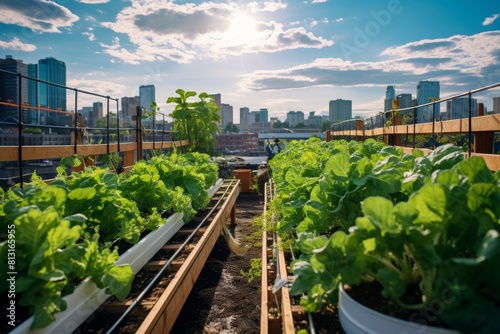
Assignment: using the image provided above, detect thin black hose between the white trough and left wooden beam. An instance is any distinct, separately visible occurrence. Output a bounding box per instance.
[106,181,234,334]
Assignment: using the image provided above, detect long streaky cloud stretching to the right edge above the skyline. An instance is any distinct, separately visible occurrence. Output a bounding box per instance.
[240,31,500,91]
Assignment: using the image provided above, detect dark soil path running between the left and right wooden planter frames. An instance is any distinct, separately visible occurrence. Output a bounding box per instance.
[171,193,342,334]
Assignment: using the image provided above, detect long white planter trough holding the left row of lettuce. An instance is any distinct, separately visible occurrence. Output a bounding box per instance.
[9,179,223,334]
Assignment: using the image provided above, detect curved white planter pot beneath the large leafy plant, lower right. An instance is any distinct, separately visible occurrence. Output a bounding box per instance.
[339,284,459,334]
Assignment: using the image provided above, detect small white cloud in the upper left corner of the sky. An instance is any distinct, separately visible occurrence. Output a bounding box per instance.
[0,0,78,33]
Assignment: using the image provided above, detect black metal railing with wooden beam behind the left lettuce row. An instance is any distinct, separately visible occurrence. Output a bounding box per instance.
[0,69,185,188]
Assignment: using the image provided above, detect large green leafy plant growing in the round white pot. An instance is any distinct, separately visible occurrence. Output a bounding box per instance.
[291,155,500,333]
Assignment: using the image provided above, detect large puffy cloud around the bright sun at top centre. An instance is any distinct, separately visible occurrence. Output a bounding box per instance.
[101,0,333,63]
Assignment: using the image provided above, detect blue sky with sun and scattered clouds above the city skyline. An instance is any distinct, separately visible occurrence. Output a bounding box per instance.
[0,0,500,123]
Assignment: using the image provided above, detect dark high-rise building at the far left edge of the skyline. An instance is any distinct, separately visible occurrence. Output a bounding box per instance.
[0,56,28,123]
